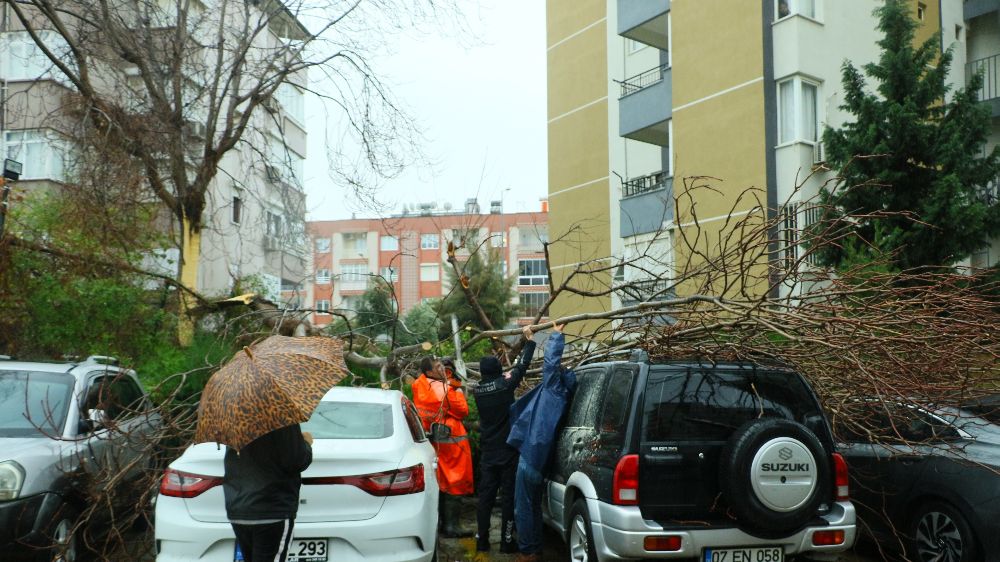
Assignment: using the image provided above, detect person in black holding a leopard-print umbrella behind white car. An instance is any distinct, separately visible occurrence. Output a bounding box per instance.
[195,336,348,562]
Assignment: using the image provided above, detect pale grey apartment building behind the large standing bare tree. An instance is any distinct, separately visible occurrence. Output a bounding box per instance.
[0,3,309,301]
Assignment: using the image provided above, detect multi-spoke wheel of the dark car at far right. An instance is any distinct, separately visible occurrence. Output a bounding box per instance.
[910,502,980,562]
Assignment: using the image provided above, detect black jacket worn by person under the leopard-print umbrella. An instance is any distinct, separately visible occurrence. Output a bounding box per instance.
[222,424,312,521]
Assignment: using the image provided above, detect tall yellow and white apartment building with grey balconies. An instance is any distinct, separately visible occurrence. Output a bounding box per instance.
[547,0,1000,315]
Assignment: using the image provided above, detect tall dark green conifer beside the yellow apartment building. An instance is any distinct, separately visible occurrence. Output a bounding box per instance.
[820,0,1000,270]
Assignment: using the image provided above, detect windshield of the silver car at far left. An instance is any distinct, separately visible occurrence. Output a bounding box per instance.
[0,371,74,437]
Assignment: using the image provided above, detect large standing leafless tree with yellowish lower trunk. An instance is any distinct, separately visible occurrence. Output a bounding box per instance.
[5,0,457,340]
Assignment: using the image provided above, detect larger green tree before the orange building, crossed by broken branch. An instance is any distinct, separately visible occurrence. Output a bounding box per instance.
[438,249,518,333]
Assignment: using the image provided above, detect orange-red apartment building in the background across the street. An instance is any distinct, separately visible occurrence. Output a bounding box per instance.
[308,200,549,326]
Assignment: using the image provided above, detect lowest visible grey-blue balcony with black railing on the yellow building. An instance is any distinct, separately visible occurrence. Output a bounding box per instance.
[619,168,674,234]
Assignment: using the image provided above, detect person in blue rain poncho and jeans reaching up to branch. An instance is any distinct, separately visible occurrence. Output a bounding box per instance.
[507,324,576,562]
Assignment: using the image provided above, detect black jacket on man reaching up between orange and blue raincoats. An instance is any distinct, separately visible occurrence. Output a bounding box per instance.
[472,340,535,465]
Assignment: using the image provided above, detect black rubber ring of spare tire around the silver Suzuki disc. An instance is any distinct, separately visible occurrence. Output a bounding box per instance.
[719,418,833,537]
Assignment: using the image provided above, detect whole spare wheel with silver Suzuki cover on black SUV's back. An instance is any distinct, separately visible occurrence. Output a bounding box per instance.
[719,418,832,536]
